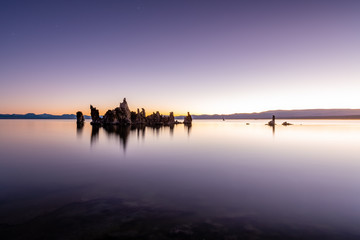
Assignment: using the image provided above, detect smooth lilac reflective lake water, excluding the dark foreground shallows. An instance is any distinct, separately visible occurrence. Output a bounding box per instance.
[0,120,360,236]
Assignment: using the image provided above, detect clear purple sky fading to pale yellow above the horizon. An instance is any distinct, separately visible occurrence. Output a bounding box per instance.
[0,0,360,115]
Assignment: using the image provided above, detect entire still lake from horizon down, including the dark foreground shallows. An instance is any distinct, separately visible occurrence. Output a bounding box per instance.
[0,120,360,239]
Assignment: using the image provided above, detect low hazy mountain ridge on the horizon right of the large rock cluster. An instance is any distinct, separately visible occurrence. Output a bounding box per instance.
[177,109,360,119]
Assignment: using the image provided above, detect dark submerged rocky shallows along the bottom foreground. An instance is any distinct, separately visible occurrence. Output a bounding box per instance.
[0,199,360,240]
